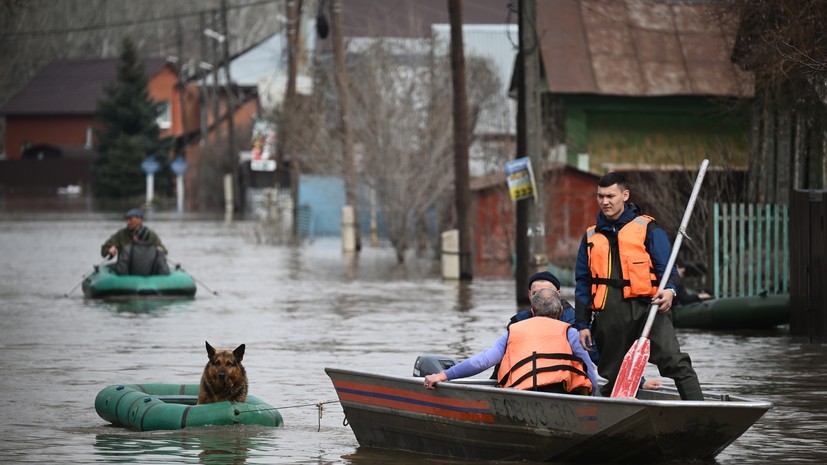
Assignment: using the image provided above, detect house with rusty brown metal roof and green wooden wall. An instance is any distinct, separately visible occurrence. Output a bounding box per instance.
[537,0,753,174]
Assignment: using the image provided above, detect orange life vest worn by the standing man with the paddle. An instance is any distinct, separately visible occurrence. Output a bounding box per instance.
[586,215,658,310]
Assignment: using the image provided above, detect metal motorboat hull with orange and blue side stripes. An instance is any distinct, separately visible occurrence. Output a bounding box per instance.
[325,368,772,463]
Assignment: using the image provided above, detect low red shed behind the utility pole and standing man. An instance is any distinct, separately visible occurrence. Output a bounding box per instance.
[471,164,599,277]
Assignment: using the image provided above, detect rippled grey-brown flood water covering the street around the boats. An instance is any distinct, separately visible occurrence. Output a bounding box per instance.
[0,213,827,465]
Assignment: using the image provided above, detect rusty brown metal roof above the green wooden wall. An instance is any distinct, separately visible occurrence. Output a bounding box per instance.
[537,0,754,97]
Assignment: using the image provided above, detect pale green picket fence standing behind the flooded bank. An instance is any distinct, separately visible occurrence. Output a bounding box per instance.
[710,203,790,297]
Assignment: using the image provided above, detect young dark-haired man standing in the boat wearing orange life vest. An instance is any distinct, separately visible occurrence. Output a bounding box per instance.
[574,173,703,400]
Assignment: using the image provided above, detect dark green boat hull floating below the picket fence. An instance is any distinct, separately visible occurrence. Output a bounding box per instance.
[672,294,790,330]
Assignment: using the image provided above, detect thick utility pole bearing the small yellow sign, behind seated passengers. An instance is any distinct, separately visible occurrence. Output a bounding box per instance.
[516,0,548,303]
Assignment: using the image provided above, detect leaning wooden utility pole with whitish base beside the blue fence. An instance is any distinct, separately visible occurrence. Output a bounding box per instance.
[330,0,362,252]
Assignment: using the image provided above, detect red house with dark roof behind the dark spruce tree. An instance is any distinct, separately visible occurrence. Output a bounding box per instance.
[0,59,198,193]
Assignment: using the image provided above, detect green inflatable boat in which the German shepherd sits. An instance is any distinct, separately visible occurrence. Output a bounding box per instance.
[95,384,284,431]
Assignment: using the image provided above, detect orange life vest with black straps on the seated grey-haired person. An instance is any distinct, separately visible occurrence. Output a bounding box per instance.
[497,317,592,394]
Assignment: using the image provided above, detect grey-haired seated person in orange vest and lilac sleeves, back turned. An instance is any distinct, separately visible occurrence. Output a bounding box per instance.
[424,288,598,395]
